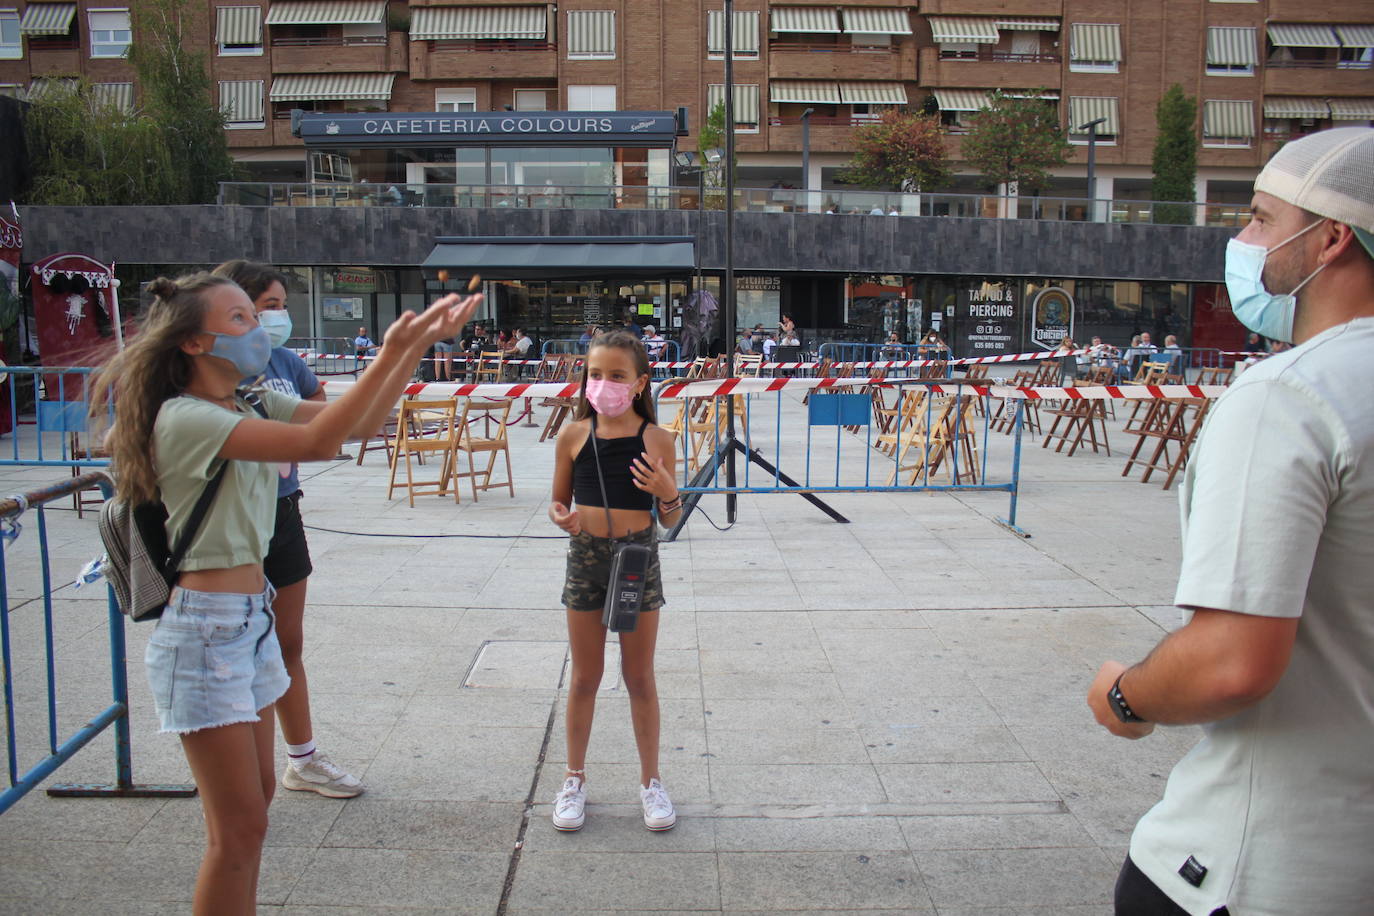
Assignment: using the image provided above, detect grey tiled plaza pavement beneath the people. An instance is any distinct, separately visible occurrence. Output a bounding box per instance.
[0,390,1197,916]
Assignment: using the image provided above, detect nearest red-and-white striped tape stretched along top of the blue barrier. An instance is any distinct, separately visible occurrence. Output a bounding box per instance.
[318,378,1226,401]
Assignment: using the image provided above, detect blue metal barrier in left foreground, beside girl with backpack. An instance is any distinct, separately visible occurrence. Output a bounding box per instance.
[0,472,195,814]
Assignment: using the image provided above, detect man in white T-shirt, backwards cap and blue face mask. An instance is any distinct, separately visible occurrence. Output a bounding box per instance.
[1088,128,1374,916]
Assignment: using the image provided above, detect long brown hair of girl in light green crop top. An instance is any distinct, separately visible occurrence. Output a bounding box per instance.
[89,272,234,503]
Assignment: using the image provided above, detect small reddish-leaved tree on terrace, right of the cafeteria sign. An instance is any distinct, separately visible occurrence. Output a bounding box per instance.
[841,108,949,191]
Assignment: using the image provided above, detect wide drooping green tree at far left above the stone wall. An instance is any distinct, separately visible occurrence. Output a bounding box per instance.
[25,80,176,206]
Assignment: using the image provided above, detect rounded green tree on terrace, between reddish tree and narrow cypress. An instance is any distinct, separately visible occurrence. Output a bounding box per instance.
[960,89,1072,191]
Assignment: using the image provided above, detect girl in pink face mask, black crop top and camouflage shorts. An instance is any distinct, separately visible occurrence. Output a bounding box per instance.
[548,331,682,831]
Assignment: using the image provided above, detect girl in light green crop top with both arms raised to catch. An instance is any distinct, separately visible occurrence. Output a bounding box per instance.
[91,273,481,915]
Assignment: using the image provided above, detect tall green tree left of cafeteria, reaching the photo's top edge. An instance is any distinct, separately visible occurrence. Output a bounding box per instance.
[129,0,238,203]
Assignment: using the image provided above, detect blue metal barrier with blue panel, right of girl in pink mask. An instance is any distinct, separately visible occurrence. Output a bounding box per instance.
[655,379,1028,537]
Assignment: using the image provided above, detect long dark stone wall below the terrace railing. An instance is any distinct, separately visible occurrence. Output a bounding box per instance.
[21,206,1235,283]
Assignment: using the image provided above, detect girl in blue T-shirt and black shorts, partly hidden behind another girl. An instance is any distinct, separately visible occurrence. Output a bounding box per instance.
[214,261,363,798]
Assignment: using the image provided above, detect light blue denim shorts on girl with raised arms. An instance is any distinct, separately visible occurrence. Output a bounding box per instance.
[144,585,291,735]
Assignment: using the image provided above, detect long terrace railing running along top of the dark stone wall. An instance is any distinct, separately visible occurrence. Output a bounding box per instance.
[220,181,1250,227]
